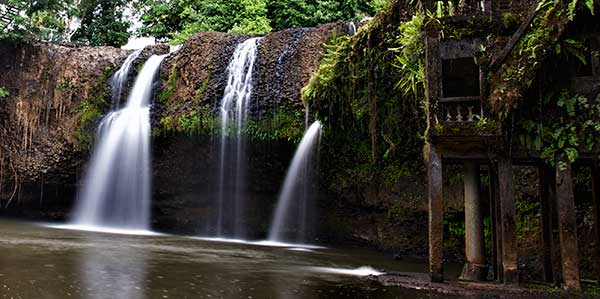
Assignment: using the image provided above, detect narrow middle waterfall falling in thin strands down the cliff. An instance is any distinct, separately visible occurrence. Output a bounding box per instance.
[216,38,260,238]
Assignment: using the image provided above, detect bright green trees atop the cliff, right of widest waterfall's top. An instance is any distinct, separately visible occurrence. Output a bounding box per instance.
[135,0,391,44]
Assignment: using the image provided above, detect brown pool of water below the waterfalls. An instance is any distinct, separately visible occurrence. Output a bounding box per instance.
[0,222,462,299]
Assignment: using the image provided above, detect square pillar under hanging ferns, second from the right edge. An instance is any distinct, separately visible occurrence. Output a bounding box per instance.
[556,163,581,291]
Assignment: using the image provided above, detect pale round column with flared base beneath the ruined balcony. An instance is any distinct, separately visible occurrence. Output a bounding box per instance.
[460,161,487,281]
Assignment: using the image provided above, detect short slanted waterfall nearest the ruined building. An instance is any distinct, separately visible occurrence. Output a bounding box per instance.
[269,121,322,243]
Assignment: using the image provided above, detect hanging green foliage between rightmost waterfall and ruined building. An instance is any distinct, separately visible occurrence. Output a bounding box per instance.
[302,1,425,197]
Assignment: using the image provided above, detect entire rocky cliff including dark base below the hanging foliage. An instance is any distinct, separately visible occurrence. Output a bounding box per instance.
[0,23,468,253]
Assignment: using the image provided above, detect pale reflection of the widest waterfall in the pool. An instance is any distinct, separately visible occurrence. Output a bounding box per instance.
[79,236,148,299]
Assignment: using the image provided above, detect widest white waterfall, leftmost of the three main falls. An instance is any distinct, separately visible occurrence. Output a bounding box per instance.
[73,55,166,230]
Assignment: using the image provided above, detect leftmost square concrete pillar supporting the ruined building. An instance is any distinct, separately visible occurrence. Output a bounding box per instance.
[427,143,444,282]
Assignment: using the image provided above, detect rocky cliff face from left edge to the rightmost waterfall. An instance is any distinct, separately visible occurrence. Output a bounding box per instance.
[0,23,348,233]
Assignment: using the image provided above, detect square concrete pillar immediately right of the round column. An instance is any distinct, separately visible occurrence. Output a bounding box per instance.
[498,157,519,284]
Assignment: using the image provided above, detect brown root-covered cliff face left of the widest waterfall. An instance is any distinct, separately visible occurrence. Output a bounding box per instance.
[0,41,127,216]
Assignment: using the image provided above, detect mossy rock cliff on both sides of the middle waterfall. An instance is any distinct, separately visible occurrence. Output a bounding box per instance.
[148,23,348,238]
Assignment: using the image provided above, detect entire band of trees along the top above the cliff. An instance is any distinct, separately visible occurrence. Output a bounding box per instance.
[0,0,388,46]
